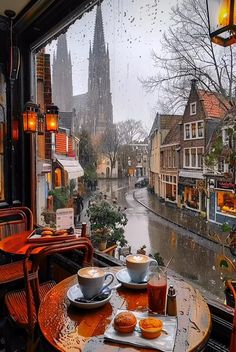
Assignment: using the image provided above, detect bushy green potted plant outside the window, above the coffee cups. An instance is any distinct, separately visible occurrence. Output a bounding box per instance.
[87,197,128,250]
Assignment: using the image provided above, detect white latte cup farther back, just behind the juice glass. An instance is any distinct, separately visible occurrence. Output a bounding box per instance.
[126,254,157,283]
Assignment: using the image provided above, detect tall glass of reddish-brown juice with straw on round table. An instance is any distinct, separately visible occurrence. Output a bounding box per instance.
[147,266,167,314]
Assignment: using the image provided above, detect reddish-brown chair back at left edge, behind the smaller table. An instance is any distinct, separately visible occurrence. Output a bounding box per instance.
[0,207,33,239]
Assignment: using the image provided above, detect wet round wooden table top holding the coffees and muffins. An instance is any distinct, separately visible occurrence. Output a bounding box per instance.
[38,267,211,352]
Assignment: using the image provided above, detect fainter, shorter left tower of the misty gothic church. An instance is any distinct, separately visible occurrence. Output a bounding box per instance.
[52,34,73,112]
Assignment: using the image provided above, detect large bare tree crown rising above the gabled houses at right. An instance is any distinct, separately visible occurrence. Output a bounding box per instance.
[141,0,236,113]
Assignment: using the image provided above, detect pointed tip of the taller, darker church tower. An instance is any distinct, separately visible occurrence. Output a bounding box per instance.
[93,4,106,56]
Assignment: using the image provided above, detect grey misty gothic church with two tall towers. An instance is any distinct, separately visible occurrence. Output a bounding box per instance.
[53,5,113,136]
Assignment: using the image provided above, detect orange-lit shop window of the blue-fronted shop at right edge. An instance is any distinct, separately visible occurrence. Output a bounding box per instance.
[217,191,236,216]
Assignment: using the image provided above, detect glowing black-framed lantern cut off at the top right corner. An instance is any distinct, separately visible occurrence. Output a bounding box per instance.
[206,0,236,46]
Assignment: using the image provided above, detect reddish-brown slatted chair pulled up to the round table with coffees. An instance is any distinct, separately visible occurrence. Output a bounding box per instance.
[5,238,92,341]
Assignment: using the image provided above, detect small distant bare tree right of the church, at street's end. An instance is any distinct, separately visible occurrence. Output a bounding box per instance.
[117,119,148,144]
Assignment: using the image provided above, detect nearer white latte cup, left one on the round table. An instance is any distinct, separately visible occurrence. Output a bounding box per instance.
[77,267,115,299]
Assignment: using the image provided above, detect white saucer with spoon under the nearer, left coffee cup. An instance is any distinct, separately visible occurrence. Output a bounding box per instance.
[67,284,112,309]
